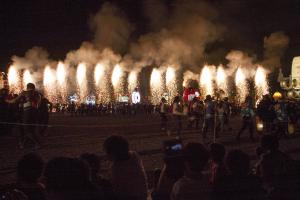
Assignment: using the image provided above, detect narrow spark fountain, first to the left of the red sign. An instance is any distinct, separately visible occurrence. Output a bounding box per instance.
[166,67,177,103]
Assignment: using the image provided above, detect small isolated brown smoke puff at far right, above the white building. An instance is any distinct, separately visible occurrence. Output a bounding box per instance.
[262,31,290,69]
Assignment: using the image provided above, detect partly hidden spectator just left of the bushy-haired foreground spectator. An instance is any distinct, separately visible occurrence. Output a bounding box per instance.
[80,153,115,200]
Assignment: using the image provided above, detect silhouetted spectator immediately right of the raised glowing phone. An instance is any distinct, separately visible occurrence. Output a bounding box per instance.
[171,143,211,200]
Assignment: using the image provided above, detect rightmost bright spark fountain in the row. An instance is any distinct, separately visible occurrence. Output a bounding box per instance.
[254,66,269,102]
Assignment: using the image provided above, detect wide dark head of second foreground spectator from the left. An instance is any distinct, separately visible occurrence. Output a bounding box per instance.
[44,157,90,192]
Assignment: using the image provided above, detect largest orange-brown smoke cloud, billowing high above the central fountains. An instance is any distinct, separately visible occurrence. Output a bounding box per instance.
[130,0,225,71]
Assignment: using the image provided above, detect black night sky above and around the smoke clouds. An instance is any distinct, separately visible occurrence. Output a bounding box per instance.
[0,0,300,72]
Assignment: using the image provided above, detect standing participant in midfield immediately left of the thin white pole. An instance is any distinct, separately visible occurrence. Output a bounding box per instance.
[202,95,215,140]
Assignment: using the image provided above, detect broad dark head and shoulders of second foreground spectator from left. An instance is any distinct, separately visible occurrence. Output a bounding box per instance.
[44,157,104,200]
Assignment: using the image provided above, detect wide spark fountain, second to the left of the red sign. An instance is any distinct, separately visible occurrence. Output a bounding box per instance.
[150,68,164,105]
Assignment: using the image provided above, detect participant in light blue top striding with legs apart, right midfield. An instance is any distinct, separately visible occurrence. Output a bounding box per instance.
[236,102,254,141]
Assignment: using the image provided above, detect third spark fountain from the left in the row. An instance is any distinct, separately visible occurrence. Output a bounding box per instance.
[43,65,57,103]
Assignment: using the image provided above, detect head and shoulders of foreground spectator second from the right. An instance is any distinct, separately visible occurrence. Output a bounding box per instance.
[213,150,265,200]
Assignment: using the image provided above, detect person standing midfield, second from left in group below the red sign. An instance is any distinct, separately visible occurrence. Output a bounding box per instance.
[172,96,184,138]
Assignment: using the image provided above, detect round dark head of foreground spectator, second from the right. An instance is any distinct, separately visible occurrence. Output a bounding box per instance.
[226,150,250,176]
